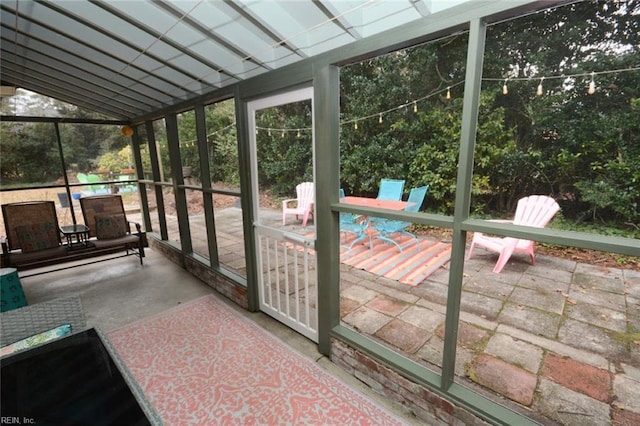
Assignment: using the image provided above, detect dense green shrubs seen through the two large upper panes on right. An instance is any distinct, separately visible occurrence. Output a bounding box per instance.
[341,1,640,229]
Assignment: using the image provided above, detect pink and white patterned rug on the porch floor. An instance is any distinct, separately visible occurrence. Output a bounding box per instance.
[109,295,402,425]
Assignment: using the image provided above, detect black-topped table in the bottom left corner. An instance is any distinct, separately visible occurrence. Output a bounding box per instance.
[0,328,162,426]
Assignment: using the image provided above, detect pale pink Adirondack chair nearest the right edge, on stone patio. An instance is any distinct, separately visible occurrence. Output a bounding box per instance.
[467,195,560,274]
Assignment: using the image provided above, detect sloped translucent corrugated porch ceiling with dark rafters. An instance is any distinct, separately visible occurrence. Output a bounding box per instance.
[0,0,467,119]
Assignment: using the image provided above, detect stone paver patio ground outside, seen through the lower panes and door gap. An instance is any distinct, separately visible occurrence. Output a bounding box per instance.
[145,208,640,425]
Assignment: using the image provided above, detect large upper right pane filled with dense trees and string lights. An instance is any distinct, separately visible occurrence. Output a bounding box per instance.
[472,2,640,243]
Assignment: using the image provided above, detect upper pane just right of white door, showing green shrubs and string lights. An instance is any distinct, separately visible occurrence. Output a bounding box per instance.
[340,34,468,208]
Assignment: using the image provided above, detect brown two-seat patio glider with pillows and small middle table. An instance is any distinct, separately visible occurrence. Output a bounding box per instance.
[2,195,146,275]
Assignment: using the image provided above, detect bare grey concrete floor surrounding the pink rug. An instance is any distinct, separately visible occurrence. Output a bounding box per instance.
[21,249,424,424]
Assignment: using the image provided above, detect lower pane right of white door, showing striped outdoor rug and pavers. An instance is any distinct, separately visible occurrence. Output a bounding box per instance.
[340,220,451,371]
